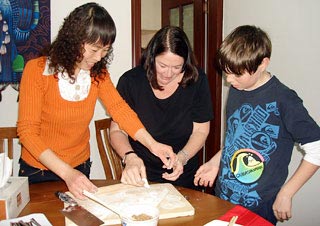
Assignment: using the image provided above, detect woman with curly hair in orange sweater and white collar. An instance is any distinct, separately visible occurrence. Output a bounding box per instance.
[17,3,176,198]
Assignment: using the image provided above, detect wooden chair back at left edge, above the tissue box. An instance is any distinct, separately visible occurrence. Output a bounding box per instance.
[0,127,18,159]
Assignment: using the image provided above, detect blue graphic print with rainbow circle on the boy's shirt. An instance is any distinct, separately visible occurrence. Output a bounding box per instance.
[219,102,279,207]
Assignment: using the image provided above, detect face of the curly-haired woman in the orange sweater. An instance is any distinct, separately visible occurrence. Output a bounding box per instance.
[77,43,110,70]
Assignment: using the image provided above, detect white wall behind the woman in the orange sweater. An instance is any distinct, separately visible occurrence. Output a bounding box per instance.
[0,0,132,179]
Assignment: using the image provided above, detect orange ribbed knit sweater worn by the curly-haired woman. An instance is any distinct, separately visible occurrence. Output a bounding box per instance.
[17,57,143,169]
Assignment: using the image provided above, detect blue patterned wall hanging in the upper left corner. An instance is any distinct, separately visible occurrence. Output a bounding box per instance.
[0,0,51,101]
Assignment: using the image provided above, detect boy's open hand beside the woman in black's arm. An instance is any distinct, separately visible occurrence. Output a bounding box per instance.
[193,161,219,187]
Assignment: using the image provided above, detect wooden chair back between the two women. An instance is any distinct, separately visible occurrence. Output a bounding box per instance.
[94,118,122,180]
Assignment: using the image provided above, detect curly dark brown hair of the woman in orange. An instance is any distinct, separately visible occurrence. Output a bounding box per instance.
[43,2,116,81]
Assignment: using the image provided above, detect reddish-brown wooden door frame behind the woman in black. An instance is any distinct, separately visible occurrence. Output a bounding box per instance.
[131,0,223,162]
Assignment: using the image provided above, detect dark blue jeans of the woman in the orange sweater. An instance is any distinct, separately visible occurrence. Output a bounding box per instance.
[19,158,92,184]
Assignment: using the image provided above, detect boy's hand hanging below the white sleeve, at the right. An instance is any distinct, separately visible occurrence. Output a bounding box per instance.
[272,190,292,222]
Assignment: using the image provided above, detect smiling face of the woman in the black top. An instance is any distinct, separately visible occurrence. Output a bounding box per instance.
[156,52,184,86]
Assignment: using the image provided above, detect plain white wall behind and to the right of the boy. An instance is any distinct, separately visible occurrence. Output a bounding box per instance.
[222,0,320,226]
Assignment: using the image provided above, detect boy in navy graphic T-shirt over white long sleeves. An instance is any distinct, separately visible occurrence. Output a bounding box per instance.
[194,25,320,224]
